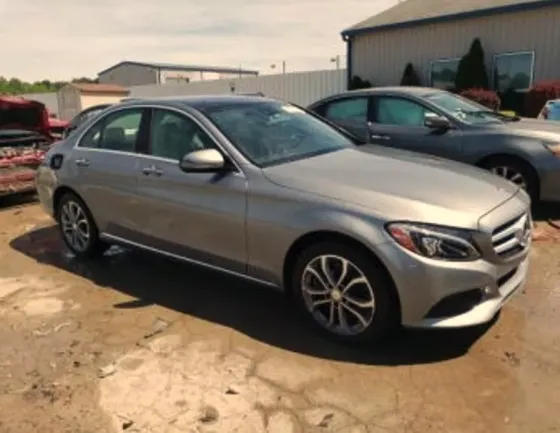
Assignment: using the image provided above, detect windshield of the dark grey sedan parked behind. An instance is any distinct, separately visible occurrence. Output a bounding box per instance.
[425,92,507,124]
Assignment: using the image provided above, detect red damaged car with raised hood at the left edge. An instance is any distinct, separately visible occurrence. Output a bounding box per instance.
[0,96,58,197]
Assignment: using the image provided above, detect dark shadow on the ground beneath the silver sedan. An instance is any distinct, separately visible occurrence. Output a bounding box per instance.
[10,226,497,365]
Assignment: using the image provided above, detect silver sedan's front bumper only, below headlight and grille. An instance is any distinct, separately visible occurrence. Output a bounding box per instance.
[381,238,530,328]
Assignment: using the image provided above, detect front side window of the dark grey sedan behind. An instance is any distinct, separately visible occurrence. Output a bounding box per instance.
[376,97,431,126]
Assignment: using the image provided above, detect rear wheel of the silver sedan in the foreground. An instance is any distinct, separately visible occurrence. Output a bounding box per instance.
[55,193,109,259]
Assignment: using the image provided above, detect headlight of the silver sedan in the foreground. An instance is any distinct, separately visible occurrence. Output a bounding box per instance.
[386,223,480,261]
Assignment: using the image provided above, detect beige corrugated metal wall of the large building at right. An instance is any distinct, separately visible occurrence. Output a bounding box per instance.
[352,7,560,86]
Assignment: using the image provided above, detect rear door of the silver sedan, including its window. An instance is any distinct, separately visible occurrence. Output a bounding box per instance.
[69,107,149,234]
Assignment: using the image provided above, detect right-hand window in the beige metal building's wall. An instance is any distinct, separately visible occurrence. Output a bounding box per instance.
[492,51,535,92]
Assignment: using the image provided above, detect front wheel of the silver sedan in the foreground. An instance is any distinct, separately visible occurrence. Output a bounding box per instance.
[292,243,400,344]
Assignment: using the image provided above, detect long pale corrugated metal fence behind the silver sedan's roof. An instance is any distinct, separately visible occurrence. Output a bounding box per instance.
[129,69,346,105]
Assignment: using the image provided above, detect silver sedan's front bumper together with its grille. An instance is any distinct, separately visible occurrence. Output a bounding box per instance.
[378,187,531,328]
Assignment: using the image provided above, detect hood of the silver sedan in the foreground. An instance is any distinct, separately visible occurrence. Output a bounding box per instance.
[263,145,519,228]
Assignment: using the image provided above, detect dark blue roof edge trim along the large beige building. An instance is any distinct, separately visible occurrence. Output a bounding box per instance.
[341,0,560,41]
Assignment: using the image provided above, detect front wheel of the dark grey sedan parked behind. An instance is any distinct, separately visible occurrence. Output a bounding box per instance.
[481,157,539,203]
